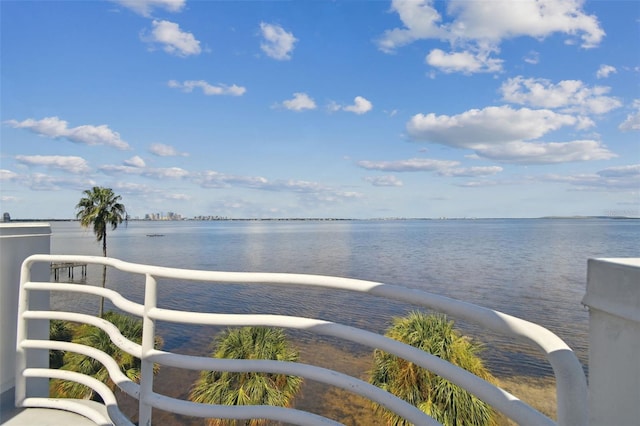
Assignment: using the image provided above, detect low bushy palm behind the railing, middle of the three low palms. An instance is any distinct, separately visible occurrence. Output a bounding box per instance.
[189,327,302,426]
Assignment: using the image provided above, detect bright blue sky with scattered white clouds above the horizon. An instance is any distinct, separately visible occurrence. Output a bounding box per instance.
[0,0,640,218]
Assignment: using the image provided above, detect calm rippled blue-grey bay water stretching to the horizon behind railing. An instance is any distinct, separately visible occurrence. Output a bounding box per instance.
[51,219,640,376]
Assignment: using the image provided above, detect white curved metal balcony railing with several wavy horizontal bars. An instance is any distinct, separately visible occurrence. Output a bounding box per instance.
[15,255,587,425]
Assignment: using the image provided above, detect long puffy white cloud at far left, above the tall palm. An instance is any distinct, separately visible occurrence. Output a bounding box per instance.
[5,117,130,150]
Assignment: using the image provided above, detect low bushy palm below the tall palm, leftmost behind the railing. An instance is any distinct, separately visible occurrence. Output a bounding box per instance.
[51,311,162,399]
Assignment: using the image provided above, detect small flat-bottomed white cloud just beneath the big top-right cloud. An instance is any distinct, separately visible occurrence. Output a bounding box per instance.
[425,49,503,74]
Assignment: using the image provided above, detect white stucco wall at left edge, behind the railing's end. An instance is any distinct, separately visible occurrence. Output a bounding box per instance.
[0,223,51,400]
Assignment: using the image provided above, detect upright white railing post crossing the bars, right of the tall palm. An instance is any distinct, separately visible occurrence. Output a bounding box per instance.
[138,274,158,426]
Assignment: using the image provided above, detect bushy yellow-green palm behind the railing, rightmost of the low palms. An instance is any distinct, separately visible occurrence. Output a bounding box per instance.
[370,312,496,426]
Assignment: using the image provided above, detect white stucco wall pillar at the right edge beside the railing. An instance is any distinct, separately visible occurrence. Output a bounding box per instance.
[583,258,640,425]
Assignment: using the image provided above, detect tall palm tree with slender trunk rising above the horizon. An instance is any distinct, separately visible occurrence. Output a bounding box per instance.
[76,186,126,317]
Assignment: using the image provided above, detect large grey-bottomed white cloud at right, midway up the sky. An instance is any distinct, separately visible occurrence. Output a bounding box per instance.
[407,106,615,164]
